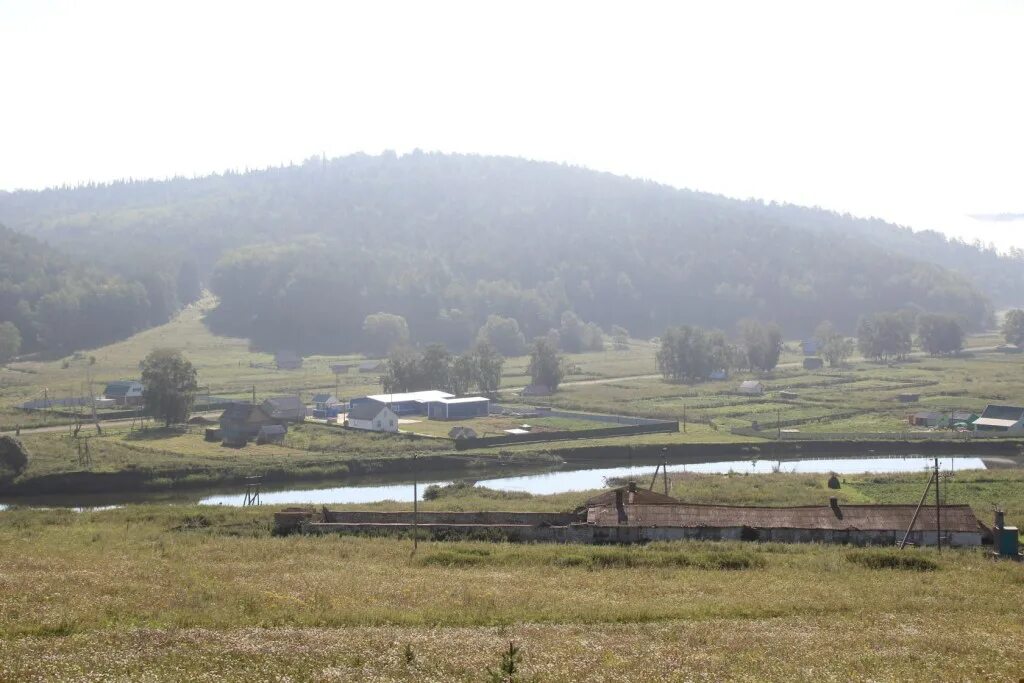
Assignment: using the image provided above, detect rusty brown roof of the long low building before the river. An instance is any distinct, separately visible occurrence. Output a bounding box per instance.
[587,504,984,531]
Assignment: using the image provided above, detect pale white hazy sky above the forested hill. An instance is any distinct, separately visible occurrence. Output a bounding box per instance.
[0,0,1024,247]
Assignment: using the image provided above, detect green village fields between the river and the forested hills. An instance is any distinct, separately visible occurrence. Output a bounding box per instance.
[6,299,1024,497]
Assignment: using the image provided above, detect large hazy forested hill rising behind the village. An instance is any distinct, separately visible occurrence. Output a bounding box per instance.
[0,154,1007,351]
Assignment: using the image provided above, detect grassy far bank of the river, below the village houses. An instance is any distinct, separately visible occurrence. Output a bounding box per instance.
[0,424,1024,506]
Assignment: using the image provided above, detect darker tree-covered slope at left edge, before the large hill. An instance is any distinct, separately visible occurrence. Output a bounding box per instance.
[0,225,198,356]
